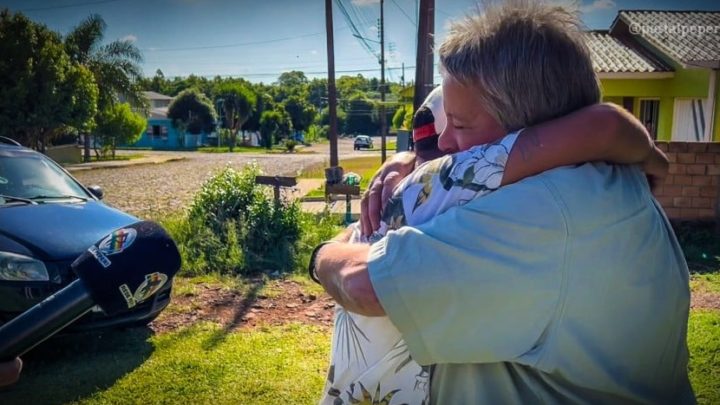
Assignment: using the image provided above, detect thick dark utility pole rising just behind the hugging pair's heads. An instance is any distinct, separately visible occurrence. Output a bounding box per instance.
[413,0,435,111]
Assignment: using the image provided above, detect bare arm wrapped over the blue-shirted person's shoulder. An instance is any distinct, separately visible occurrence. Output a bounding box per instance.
[502,103,668,185]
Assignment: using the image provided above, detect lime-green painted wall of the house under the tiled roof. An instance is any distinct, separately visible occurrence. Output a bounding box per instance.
[600,65,720,141]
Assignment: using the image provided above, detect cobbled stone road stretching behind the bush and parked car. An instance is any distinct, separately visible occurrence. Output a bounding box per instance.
[73,139,390,219]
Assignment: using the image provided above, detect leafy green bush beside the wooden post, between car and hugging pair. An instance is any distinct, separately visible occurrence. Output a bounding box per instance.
[168,164,301,275]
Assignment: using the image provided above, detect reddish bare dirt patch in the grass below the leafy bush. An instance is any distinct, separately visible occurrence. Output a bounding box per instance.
[149,280,335,333]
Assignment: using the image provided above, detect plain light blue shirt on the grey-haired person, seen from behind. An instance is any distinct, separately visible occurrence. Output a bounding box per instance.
[369,163,695,404]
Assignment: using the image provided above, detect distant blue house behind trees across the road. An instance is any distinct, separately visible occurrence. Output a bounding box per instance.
[130,91,214,149]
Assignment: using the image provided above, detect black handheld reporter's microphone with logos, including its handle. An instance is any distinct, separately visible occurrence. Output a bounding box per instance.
[0,221,181,361]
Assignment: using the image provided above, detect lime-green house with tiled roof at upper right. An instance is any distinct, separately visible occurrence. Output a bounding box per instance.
[588,10,720,142]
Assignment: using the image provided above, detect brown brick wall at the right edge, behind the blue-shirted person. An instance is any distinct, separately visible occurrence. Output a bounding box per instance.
[654,142,720,220]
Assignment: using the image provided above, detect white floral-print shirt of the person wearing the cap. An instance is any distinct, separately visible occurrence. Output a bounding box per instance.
[320,131,520,405]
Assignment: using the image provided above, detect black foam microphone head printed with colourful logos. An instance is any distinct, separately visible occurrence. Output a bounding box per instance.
[71,221,181,315]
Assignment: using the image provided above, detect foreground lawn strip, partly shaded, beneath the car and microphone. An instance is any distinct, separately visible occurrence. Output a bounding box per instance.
[0,323,330,405]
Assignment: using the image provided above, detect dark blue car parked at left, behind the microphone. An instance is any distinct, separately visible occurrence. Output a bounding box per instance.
[0,137,172,331]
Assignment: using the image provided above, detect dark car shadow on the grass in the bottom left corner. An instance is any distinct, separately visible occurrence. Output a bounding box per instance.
[0,327,153,405]
